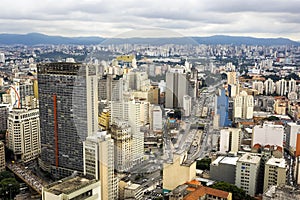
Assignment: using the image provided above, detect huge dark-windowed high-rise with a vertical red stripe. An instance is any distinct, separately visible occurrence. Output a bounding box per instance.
[38,63,98,178]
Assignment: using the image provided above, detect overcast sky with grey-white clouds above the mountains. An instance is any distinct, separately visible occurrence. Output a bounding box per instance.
[0,0,300,41]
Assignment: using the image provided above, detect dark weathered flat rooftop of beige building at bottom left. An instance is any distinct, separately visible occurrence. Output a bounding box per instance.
[46,176,96,195]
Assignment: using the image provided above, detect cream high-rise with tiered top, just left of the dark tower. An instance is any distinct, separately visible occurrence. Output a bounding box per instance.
[7,109,41,163]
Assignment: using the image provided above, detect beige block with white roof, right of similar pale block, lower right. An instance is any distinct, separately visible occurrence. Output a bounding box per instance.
[264,157,286,191]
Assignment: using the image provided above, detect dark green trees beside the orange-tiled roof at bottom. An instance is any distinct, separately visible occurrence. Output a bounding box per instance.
[211,182,254,200]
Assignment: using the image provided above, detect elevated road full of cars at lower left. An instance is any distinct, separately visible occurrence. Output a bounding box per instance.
[6,163,47,195]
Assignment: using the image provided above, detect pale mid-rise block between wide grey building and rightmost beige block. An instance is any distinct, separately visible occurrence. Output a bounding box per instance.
[235,153,261,196]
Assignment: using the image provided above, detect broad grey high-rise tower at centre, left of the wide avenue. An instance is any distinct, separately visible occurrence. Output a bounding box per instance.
[166,71,189,108]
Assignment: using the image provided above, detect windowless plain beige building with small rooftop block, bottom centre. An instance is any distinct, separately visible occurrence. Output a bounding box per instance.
[163,154,196,190]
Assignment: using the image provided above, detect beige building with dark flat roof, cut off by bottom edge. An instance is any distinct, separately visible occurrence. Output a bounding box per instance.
[42,176,101,200]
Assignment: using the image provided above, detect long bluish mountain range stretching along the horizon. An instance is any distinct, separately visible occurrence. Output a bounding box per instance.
[0,33,300,46]
